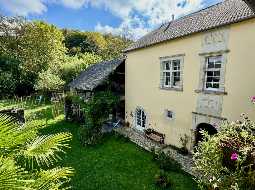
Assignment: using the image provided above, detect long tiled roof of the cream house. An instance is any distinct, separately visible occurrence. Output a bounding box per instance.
[125,0,255,52]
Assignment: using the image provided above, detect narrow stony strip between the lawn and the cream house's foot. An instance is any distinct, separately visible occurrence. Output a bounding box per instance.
[114,127,198,176]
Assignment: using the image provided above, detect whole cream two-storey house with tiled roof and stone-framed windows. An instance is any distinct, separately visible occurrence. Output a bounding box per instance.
[125,0,255,149]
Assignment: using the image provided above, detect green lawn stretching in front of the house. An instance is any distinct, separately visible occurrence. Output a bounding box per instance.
[0,100,196,190]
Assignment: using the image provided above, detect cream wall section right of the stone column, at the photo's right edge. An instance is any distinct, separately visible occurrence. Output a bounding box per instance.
[223,19,255,121]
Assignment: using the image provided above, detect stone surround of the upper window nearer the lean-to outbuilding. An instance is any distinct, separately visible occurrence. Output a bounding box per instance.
[159,54,185,92]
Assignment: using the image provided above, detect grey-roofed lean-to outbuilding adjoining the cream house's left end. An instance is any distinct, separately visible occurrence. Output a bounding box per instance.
[68,58,125,120]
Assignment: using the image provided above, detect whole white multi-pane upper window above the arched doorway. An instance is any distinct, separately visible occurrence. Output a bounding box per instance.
[205,56,222,90]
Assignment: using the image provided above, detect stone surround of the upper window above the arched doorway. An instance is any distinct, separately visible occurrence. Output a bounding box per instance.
[195,50,230,95]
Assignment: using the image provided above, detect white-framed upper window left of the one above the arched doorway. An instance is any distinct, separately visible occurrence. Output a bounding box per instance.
[161,59,181,88]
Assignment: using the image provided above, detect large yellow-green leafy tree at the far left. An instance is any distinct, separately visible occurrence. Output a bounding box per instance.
[0,17,66,95]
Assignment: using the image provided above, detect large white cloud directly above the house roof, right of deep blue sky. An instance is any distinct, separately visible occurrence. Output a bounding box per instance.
[93,0,204,39]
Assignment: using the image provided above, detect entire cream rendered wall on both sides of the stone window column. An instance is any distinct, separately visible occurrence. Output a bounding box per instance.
[125,19,255,146]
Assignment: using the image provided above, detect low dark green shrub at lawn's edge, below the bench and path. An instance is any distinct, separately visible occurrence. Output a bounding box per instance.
[154,151,181,172]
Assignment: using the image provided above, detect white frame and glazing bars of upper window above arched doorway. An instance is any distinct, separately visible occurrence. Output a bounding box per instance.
[204,55,224,91]
